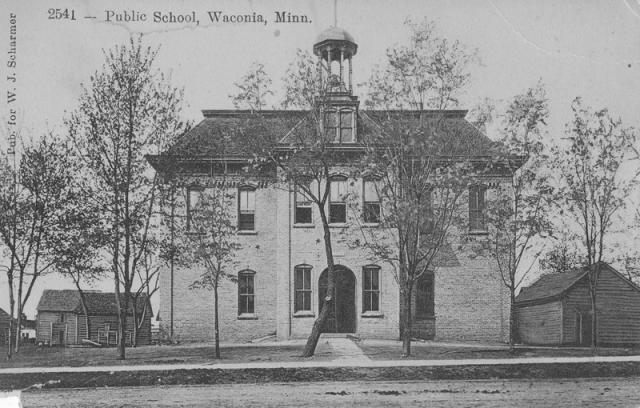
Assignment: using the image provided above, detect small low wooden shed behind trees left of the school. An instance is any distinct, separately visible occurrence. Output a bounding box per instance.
[36,290,153,345]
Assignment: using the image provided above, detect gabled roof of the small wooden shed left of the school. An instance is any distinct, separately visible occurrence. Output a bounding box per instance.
[37,289,153,316]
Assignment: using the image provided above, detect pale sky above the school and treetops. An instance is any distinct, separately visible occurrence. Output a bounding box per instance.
[0,0,640,318]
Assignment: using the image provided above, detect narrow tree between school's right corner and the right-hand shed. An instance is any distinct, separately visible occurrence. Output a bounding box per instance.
[486,83,552,353]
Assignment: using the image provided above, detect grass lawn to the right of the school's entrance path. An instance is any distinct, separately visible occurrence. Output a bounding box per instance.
[358,339,640,360]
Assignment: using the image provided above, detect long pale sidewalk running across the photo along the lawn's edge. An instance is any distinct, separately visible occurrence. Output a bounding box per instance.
[0,356,640,375]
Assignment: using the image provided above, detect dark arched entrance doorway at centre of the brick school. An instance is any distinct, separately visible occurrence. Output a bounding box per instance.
[318,265,356,333]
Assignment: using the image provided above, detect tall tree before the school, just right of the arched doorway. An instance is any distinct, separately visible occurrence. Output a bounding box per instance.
[360,20,480,356]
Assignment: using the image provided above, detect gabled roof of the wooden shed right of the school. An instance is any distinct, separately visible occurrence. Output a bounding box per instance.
[516,262,640,303]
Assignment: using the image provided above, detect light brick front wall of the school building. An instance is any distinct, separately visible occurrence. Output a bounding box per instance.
[160,177,509,342]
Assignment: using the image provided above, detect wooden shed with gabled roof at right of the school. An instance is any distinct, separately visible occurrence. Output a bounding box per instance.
[516,262,640,346]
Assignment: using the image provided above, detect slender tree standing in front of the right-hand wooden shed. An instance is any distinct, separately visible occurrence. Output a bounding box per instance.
[553,98,636,351]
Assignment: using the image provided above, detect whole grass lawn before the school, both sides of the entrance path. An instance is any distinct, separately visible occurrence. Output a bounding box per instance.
[0,339,640,368]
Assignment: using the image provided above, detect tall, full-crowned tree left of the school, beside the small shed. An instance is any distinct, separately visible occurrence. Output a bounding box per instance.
[66,38,188,360]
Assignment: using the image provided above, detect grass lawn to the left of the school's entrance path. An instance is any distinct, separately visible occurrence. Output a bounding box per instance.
[0,342,333,368]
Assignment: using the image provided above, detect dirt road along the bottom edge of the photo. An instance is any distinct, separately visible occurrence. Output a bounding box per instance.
[22,377,640,408]
